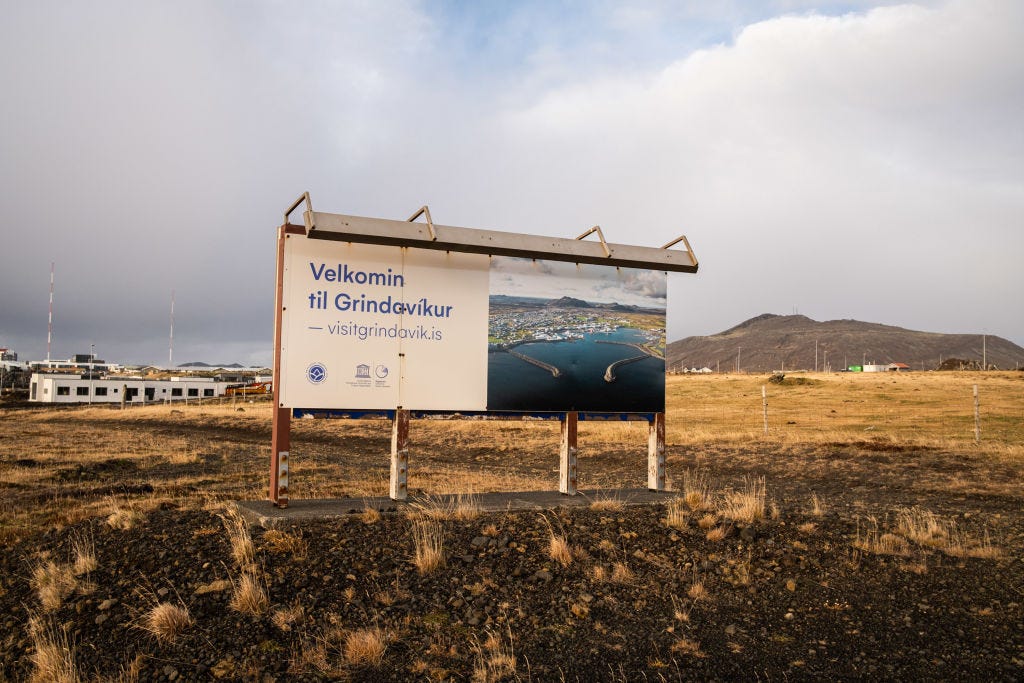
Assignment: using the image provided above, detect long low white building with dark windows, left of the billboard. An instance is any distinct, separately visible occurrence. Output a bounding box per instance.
[29,373,237,403]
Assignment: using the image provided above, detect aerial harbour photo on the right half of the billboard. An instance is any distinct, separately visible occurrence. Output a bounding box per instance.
[487,257,667,413]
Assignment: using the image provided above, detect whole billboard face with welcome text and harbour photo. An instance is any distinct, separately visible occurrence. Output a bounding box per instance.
[281,234,667,413]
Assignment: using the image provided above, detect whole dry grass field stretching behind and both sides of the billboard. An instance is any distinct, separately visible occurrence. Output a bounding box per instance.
[0,373,1024,553]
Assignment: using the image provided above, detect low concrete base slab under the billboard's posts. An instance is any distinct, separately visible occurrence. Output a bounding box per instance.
[233,488,676,528]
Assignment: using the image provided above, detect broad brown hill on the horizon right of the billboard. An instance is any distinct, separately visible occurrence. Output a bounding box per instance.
[667,313,1024,372]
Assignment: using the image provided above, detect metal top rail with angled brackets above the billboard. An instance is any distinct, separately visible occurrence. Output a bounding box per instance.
[285,193,697,272]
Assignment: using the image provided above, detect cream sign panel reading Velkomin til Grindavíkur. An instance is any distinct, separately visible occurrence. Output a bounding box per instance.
[281,236,488,411]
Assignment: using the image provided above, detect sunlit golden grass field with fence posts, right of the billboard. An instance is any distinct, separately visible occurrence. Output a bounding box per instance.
[666,369,1024,450]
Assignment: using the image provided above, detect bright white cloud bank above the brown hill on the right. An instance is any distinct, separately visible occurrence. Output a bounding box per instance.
[487,2,1024,339]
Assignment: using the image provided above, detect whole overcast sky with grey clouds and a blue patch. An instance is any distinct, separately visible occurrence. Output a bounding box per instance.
[0,0,1024,364]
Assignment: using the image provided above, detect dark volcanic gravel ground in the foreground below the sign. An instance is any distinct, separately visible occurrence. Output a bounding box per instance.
[0,483,1024,681]
